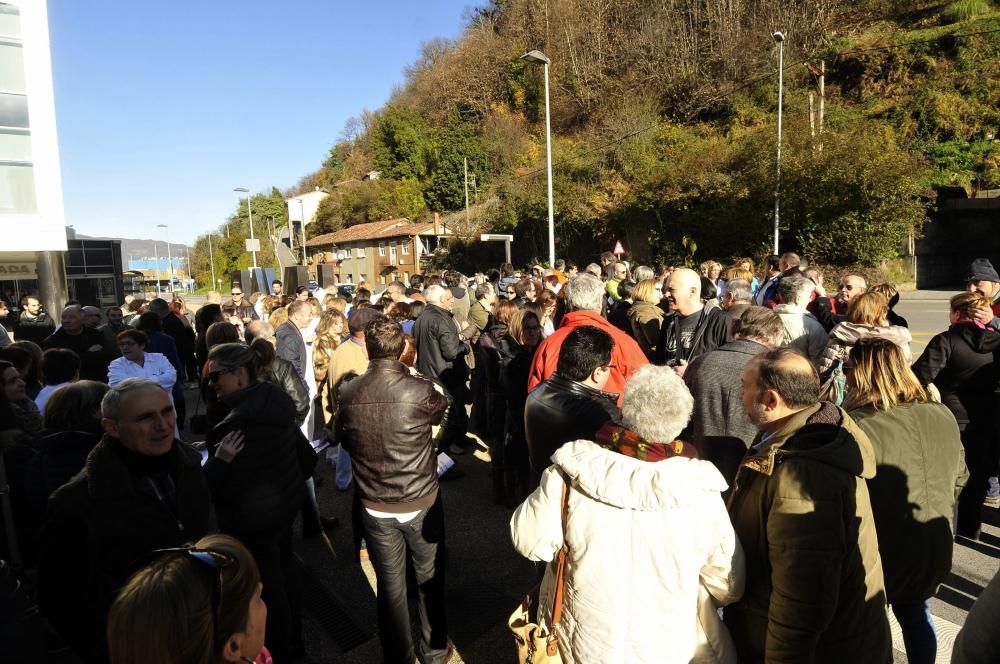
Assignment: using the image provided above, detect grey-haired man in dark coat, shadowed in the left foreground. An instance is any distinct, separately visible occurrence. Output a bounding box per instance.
[38,378,213,664]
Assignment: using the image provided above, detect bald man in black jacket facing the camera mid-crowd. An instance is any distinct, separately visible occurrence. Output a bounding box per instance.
[656,268,732,376]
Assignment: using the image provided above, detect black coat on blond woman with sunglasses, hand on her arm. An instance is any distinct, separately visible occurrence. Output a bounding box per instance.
[205,382,316,537]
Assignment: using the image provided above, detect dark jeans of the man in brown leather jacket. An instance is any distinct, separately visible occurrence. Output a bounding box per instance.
[361,497,448,664]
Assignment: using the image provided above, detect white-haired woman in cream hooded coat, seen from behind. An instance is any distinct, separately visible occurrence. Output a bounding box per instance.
[511,365,744,664]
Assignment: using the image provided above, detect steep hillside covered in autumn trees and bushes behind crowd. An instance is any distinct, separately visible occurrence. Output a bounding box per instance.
[197,0,1000,276]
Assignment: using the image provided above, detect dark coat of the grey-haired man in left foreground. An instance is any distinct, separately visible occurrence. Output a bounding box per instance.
[38,435,209,664]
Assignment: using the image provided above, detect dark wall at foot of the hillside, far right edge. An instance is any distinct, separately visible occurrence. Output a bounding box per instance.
[916,198,1000,288]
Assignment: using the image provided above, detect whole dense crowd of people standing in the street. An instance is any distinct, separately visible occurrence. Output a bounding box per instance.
[0,253,1000,664]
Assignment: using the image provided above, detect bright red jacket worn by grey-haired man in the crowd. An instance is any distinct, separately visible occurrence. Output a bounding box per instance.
[528,311,649,408]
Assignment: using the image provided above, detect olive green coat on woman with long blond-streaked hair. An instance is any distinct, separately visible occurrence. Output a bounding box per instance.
[851,403,969,604]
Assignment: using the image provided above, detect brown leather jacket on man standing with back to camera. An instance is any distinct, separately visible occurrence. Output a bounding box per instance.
[335,359,448,513]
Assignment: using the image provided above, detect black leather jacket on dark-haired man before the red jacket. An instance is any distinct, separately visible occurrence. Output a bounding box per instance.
[524,373,620,473]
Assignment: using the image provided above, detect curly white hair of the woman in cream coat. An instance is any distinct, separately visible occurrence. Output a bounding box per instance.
[622,364,694,443]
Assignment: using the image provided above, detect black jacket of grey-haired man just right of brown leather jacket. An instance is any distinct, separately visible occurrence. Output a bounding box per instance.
[413,304,471,392]
